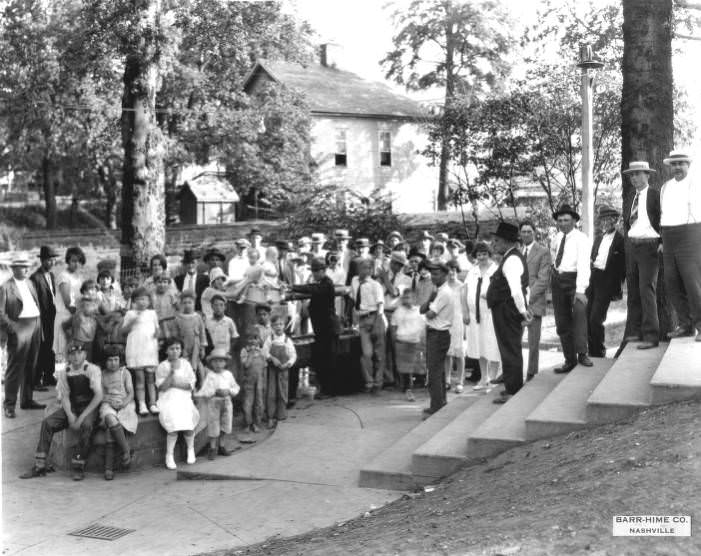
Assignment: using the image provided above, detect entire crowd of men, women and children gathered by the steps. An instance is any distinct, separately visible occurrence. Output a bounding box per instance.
[0,152,701,478]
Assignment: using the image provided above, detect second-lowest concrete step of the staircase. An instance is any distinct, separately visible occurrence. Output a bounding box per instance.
[411,388,501,479]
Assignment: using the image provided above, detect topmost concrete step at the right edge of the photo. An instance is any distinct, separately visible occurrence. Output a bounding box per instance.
[650,337,701,404]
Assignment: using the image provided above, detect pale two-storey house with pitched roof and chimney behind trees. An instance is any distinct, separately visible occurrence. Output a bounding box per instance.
[244,45,438,212]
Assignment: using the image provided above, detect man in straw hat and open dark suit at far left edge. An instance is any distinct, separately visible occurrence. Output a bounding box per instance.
[0,259,46,419]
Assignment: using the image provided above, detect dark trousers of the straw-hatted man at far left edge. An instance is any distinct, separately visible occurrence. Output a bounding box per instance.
[4,317,41,407]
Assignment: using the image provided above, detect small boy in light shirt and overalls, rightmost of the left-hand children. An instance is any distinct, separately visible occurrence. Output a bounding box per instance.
[263,315,297,429]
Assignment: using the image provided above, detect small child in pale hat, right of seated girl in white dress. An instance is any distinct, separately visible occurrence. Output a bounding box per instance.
[197,348,240,460]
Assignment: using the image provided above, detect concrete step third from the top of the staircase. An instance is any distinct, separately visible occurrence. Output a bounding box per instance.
[526,357,614,441]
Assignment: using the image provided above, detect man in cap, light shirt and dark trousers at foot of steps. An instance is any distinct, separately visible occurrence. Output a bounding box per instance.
[419,260,458,416]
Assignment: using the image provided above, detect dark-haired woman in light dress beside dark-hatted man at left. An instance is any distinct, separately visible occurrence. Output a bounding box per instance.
[53,247,85,363]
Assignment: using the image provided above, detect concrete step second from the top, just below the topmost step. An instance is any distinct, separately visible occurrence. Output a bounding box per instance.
[586,342,667,424]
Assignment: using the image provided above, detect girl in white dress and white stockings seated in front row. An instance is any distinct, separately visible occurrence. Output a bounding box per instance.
[156,338,200,469]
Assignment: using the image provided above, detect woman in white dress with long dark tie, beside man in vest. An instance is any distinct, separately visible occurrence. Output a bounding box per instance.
[462,242,501,391]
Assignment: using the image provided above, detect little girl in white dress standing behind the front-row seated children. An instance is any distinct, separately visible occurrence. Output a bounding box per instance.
[122,287,160,415]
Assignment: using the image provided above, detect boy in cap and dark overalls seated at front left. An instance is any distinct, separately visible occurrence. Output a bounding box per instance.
[20,341,102,481]
